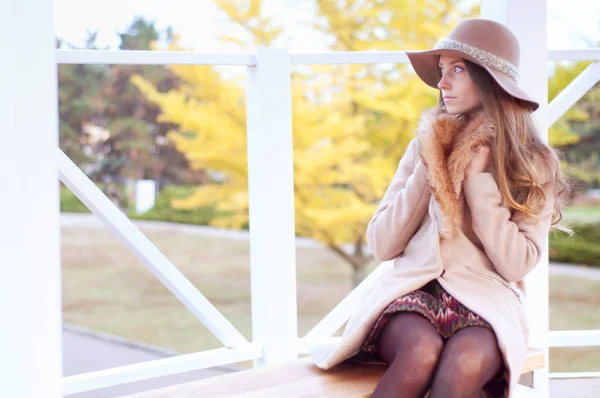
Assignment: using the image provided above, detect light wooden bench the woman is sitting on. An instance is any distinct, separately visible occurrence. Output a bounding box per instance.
[126,348,544,398]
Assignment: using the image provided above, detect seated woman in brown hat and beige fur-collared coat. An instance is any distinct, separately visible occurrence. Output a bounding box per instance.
[311,19,564,398]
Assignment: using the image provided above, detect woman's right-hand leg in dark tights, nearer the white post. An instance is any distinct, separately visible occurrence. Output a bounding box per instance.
[429,326,503,398]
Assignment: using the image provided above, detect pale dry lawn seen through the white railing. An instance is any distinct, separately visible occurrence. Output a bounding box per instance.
[62,227,600,372]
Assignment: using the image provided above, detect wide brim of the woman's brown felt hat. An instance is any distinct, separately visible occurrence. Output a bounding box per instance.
[406,49,540,112]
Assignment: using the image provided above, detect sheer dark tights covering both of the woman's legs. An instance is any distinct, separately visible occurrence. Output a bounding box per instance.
[371,312,503,398]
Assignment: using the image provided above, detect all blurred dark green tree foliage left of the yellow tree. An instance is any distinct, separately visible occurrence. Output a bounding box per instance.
[57,17,204,188]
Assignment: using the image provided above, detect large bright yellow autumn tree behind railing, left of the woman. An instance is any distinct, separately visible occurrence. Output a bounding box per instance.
[133,0,473,284]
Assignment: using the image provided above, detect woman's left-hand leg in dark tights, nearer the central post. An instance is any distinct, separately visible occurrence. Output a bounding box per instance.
[371,312,444,398]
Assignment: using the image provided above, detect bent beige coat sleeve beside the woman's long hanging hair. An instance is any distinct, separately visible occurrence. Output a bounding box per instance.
[463,173,555,282]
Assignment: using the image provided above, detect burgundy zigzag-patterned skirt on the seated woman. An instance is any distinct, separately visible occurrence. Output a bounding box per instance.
[349,279,508,397]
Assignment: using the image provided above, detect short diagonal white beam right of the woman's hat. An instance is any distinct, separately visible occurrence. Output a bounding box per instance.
[548,62,600,126]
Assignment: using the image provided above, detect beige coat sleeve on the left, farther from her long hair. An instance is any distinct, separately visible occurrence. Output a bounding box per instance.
[367,139,431,261]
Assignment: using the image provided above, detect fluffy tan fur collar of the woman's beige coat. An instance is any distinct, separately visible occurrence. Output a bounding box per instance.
[417,106,495,238]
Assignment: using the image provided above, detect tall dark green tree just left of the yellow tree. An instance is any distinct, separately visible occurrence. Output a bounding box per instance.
[99,17,188,183]
